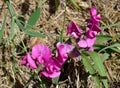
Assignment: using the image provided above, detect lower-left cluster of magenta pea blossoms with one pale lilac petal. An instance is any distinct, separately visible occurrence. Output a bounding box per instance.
[22,43,74,78]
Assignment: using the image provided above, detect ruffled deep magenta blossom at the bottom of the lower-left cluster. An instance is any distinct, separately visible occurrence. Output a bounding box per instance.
[40,58,62,78]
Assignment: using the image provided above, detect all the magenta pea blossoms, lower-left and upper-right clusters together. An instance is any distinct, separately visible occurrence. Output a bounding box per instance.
[22,7,101,78]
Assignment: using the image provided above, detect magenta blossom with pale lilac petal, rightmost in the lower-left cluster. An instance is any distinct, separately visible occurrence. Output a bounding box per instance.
[57,42,74,64]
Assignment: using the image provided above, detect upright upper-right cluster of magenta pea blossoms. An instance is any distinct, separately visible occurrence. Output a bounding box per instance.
[67,7,101,51]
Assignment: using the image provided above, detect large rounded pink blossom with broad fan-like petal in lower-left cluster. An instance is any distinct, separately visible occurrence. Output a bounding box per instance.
[32,44,52,64]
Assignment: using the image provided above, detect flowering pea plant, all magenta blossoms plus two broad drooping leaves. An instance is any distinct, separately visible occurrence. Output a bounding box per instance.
[22,7,108,88]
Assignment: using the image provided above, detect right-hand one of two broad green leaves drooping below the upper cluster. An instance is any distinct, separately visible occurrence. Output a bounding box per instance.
[88,52,108,88]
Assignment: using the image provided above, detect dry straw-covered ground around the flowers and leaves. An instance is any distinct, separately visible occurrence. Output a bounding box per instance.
[0,0,120,88]
